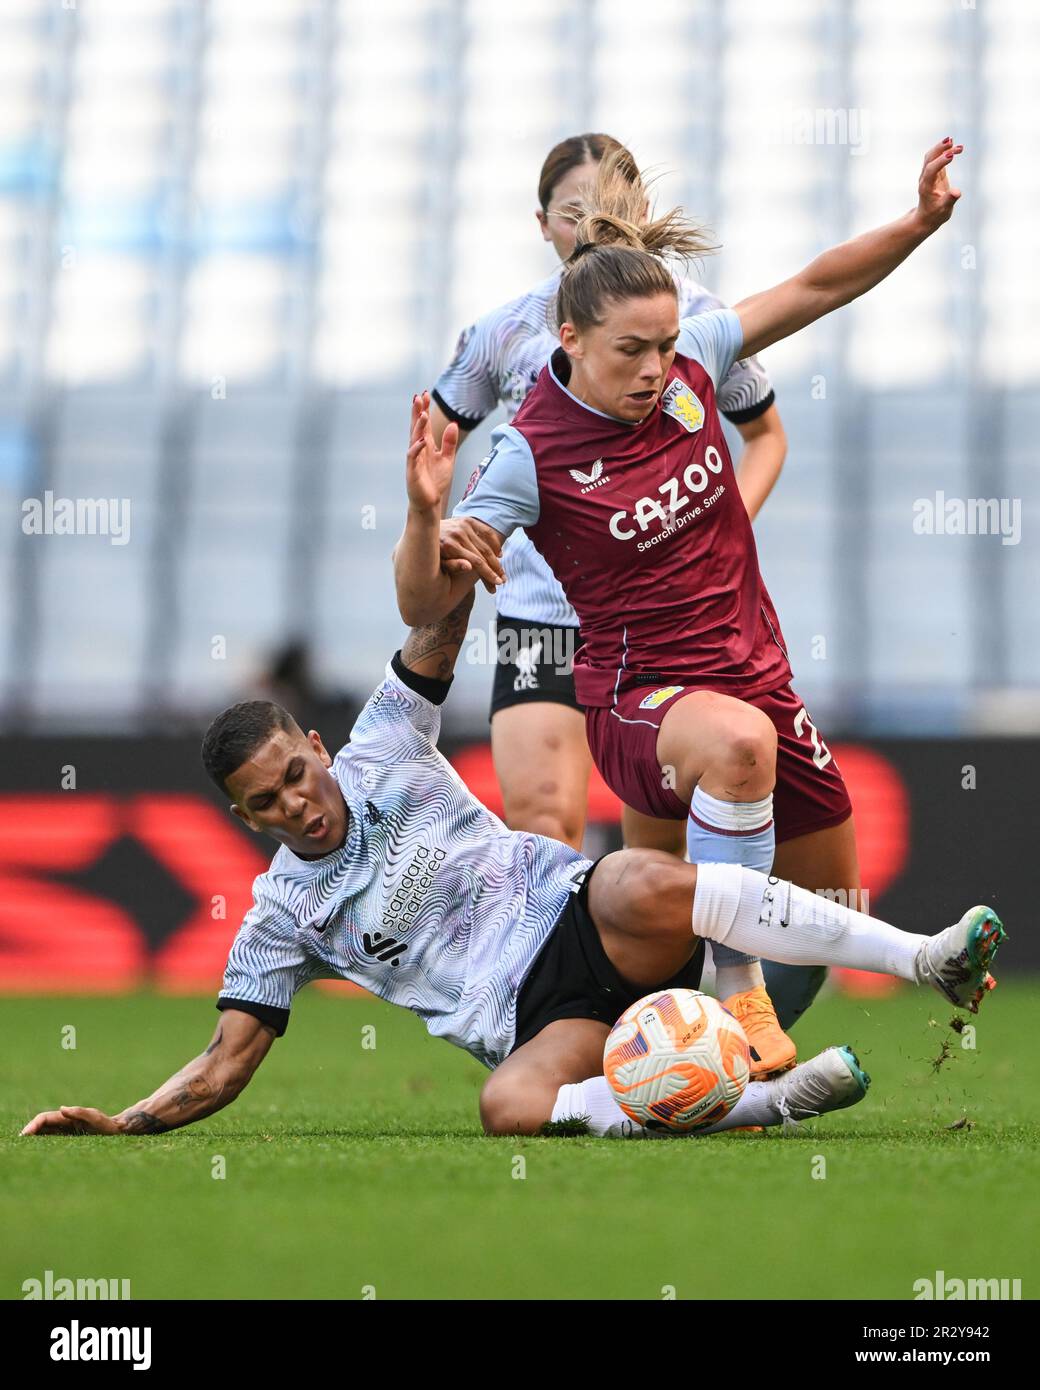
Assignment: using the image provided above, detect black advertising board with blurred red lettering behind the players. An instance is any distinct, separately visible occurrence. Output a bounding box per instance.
[0,739,1040,992]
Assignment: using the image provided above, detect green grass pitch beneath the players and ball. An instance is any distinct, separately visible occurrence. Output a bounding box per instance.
[0,980,1040,1300]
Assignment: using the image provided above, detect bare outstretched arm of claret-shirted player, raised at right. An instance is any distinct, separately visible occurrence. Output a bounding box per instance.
[734,138,964,357]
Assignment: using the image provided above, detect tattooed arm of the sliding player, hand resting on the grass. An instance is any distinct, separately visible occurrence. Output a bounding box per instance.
[22,1009,275,1134]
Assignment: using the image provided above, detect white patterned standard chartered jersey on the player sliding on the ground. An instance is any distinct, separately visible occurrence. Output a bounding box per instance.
[217,656,591,1068]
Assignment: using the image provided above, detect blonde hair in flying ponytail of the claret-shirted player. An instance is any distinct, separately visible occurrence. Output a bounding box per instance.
[556,150,717,331]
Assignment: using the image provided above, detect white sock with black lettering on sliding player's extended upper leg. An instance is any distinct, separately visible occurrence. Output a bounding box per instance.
[694,865,927,980]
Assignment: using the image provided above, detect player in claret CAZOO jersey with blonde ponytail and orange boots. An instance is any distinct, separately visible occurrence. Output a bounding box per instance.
[395,140,961,1072]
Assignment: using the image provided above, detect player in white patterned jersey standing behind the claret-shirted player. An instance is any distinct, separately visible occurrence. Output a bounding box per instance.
[430,133,787,855]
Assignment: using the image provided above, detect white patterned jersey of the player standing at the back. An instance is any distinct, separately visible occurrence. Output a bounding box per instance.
[432,267,774,627]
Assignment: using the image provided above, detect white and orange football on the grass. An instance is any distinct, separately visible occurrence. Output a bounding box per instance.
[603,990,751,1134]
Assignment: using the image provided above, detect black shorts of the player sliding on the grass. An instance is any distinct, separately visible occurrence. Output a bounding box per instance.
[510,860,704,1052]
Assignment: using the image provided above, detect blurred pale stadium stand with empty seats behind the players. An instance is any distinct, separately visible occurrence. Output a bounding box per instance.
[0,0,1040,734]
